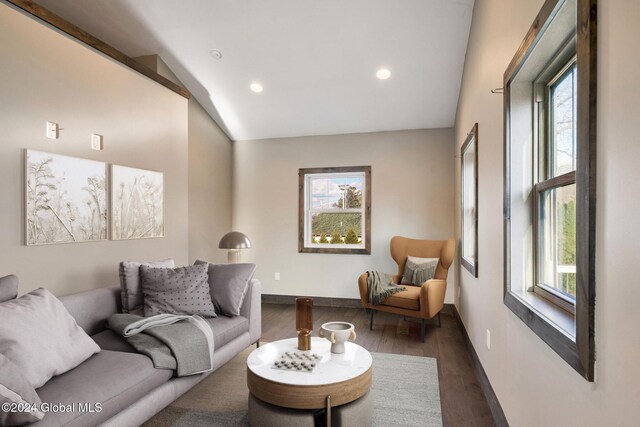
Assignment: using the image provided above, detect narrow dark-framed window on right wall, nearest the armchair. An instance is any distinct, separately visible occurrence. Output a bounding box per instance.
[460,123,478,277]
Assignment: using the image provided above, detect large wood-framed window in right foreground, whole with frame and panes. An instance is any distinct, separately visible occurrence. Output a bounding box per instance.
[504,0,597,381]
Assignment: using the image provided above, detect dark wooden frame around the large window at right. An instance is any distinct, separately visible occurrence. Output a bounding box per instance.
[503,0,597,381]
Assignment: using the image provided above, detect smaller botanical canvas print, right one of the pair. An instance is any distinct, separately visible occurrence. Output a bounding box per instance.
[111,165,164,240]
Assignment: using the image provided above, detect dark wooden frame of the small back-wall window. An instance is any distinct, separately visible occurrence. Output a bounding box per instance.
[298,166,371,255]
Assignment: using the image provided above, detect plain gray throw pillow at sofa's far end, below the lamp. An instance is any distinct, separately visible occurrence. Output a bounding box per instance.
[195,260,256,316]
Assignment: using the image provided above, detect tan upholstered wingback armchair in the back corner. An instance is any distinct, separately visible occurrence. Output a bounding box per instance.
[358,236,456,342]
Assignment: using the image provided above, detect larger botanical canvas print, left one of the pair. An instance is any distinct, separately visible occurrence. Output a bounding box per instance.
[25,150,107,245]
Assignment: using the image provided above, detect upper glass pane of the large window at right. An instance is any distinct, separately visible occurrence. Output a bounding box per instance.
[549,65,577,178]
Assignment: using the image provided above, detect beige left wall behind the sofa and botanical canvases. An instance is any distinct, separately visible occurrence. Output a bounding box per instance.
[0,3,189,295]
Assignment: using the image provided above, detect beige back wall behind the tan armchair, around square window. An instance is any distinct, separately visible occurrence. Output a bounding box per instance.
[233,129,457,302]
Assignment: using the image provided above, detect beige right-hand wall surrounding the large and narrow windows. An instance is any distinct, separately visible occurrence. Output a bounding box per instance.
[455,0,640,426]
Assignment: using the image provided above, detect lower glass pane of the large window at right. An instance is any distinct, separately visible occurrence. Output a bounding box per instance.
[538,184,576,299]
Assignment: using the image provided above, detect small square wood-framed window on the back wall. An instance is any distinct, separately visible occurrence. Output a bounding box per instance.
[298,166,371,254]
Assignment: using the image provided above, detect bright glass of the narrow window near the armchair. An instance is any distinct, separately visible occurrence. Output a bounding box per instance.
[462,143,476,263]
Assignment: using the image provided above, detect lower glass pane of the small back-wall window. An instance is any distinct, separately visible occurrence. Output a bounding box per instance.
[311,212,362,245]
